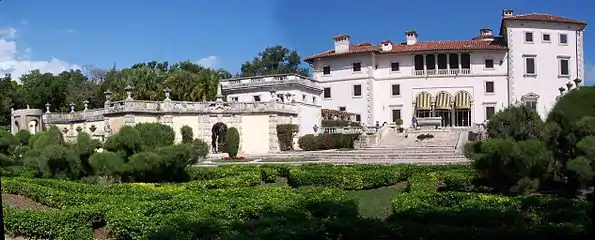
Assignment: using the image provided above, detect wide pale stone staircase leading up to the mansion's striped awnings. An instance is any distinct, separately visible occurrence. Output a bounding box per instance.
[308,130,469,164]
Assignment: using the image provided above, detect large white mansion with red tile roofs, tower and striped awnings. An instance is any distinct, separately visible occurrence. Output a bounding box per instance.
[305,9,586,127]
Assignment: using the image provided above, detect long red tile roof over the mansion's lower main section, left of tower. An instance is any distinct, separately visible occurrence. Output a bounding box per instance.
[304,38,507,63]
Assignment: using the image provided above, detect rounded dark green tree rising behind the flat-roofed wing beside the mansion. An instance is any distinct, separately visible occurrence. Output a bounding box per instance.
[241,45,310,77]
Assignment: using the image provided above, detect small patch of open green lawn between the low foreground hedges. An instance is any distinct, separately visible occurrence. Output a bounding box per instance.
[349,182,407,219]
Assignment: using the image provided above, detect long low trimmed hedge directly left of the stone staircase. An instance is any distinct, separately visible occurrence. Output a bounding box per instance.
[298,133,360,151]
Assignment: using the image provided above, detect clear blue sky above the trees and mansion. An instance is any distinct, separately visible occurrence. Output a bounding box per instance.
[0,0,595,82]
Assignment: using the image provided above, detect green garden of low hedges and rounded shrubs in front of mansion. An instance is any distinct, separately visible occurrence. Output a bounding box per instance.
[0,87,595,239]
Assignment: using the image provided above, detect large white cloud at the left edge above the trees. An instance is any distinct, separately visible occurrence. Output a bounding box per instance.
[0,28,81,80]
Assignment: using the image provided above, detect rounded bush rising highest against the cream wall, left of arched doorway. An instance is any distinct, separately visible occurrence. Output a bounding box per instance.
[134,123,176,149]
